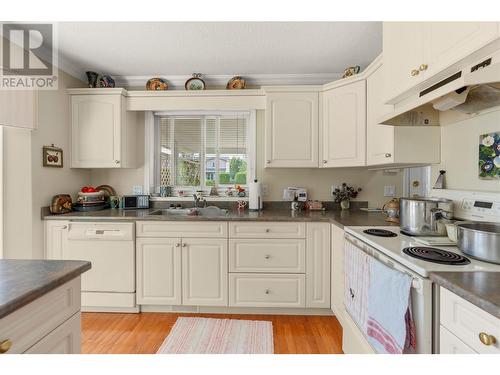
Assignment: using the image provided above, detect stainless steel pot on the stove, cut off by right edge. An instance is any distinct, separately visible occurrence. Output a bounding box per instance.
[457,222,500,264]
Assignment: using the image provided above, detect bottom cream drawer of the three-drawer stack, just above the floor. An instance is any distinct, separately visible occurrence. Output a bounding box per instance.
[229,273,306,307]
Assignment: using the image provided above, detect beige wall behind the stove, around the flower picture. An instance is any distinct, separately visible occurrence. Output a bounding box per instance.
[431,110,500,193]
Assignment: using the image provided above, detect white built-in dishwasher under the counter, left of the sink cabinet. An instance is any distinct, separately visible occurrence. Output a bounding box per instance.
[63,222,135,311]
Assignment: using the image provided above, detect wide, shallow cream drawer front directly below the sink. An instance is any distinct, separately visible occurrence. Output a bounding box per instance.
[136,221,227,238]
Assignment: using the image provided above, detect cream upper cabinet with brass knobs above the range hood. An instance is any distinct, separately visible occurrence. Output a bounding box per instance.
[383,22,500,104]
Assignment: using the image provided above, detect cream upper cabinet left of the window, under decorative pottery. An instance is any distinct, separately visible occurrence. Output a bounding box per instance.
[70,89,137,168]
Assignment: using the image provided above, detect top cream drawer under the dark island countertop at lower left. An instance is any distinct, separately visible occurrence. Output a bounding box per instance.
[0,277,80,353]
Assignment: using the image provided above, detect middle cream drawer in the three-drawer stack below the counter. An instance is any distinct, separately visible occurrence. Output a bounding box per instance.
[229,239,306,273]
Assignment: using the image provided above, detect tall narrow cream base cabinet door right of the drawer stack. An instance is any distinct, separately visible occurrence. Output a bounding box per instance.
[306,223,330,307]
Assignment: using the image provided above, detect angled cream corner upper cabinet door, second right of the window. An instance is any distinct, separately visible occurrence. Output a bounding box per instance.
[321,80,366,168]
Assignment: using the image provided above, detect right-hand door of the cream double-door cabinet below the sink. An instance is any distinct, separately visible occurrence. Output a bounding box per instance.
[182,238,228,306]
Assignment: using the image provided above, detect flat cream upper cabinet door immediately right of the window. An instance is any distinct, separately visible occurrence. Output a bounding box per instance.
[265,92,319,168]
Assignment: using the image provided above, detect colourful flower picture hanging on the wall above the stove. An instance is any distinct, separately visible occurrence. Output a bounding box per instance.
[479,132,500,179]
